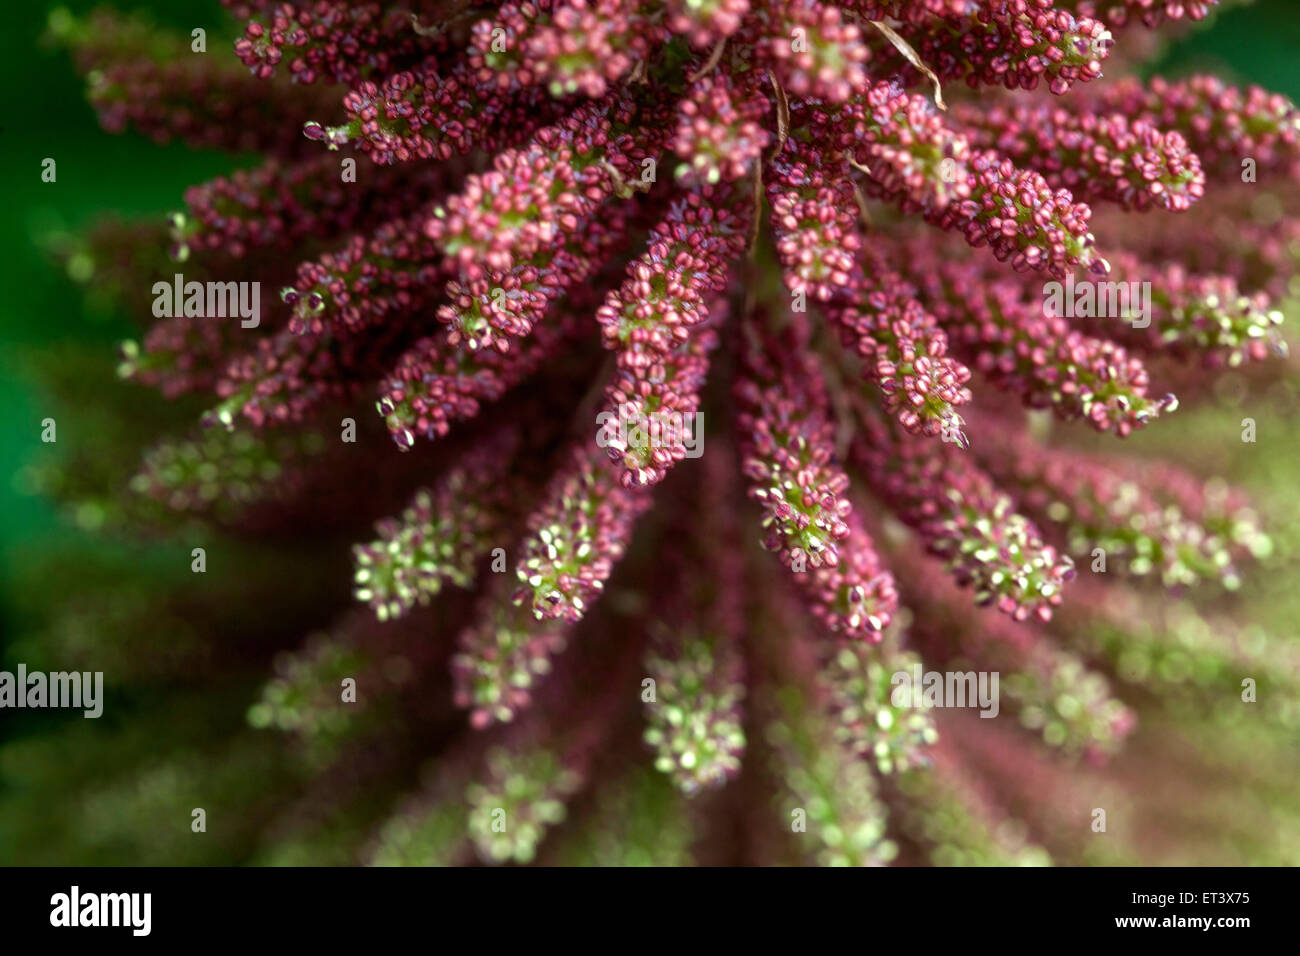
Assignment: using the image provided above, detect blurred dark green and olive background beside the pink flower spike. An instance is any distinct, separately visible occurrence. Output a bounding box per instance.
[0,0,1300,864]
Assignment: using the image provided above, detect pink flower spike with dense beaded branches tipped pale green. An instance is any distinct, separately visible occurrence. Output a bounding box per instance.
[25,0,1300,865]
